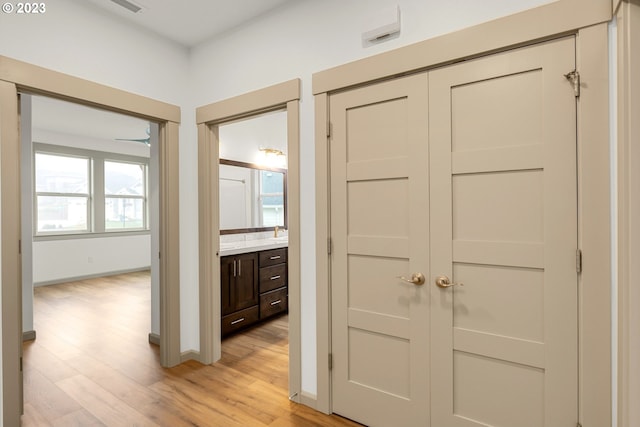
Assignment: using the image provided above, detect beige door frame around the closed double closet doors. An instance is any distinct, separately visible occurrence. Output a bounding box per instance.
[313,0,612,426]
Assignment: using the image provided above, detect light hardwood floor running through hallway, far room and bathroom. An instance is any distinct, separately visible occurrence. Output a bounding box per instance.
[22,272,359,427]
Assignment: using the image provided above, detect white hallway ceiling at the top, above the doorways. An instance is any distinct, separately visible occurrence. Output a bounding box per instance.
[78,0,295,47]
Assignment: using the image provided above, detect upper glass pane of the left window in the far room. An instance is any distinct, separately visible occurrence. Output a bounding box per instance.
[35,153,89,194]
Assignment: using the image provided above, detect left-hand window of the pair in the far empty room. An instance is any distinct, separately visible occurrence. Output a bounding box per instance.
[35,153,91,233]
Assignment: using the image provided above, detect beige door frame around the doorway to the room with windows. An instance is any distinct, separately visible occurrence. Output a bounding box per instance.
[0,56,181,425]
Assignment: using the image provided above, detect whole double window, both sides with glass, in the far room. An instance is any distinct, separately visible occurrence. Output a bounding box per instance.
[34,144,149,236]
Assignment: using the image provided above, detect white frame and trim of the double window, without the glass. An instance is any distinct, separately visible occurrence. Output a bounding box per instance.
[31,142,151,241]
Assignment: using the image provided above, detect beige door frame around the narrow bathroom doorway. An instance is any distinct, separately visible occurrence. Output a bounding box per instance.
[196,79,301,402]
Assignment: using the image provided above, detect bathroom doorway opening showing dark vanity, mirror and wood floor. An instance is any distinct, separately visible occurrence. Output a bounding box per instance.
[214,109,289,391]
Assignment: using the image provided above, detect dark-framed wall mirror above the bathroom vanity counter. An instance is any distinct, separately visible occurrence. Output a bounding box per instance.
[220,159,287,234]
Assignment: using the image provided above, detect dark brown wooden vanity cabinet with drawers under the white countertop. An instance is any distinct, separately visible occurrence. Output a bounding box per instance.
[220,248,288,336]
